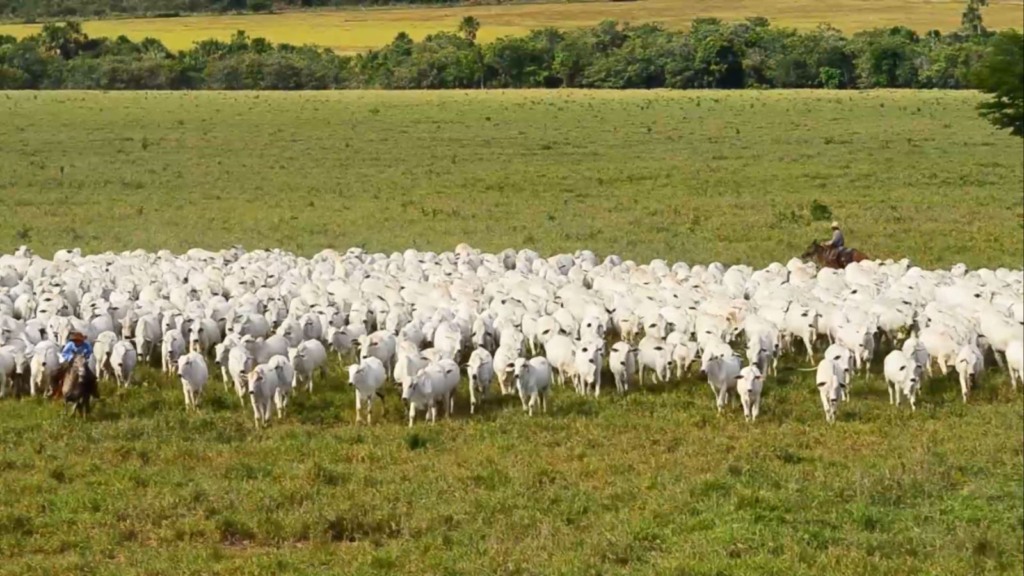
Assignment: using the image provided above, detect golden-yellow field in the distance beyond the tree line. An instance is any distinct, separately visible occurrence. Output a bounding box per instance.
[0,0,1024,52]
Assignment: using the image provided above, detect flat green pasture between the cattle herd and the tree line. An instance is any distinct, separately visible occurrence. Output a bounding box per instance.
[0,91,1024,268]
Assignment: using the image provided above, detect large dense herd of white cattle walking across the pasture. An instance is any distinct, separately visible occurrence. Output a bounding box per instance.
[0,244,1024,427]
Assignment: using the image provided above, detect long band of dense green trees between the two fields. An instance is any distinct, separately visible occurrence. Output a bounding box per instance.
[0,17,1019,90]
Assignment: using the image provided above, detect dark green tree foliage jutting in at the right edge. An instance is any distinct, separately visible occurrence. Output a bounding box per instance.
[974,30,1024,137]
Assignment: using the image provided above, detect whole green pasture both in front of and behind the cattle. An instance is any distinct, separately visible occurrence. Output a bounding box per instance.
[0,91,1024,576]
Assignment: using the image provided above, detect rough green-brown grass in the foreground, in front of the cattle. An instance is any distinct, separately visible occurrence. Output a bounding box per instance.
[0,356,1024,576]
